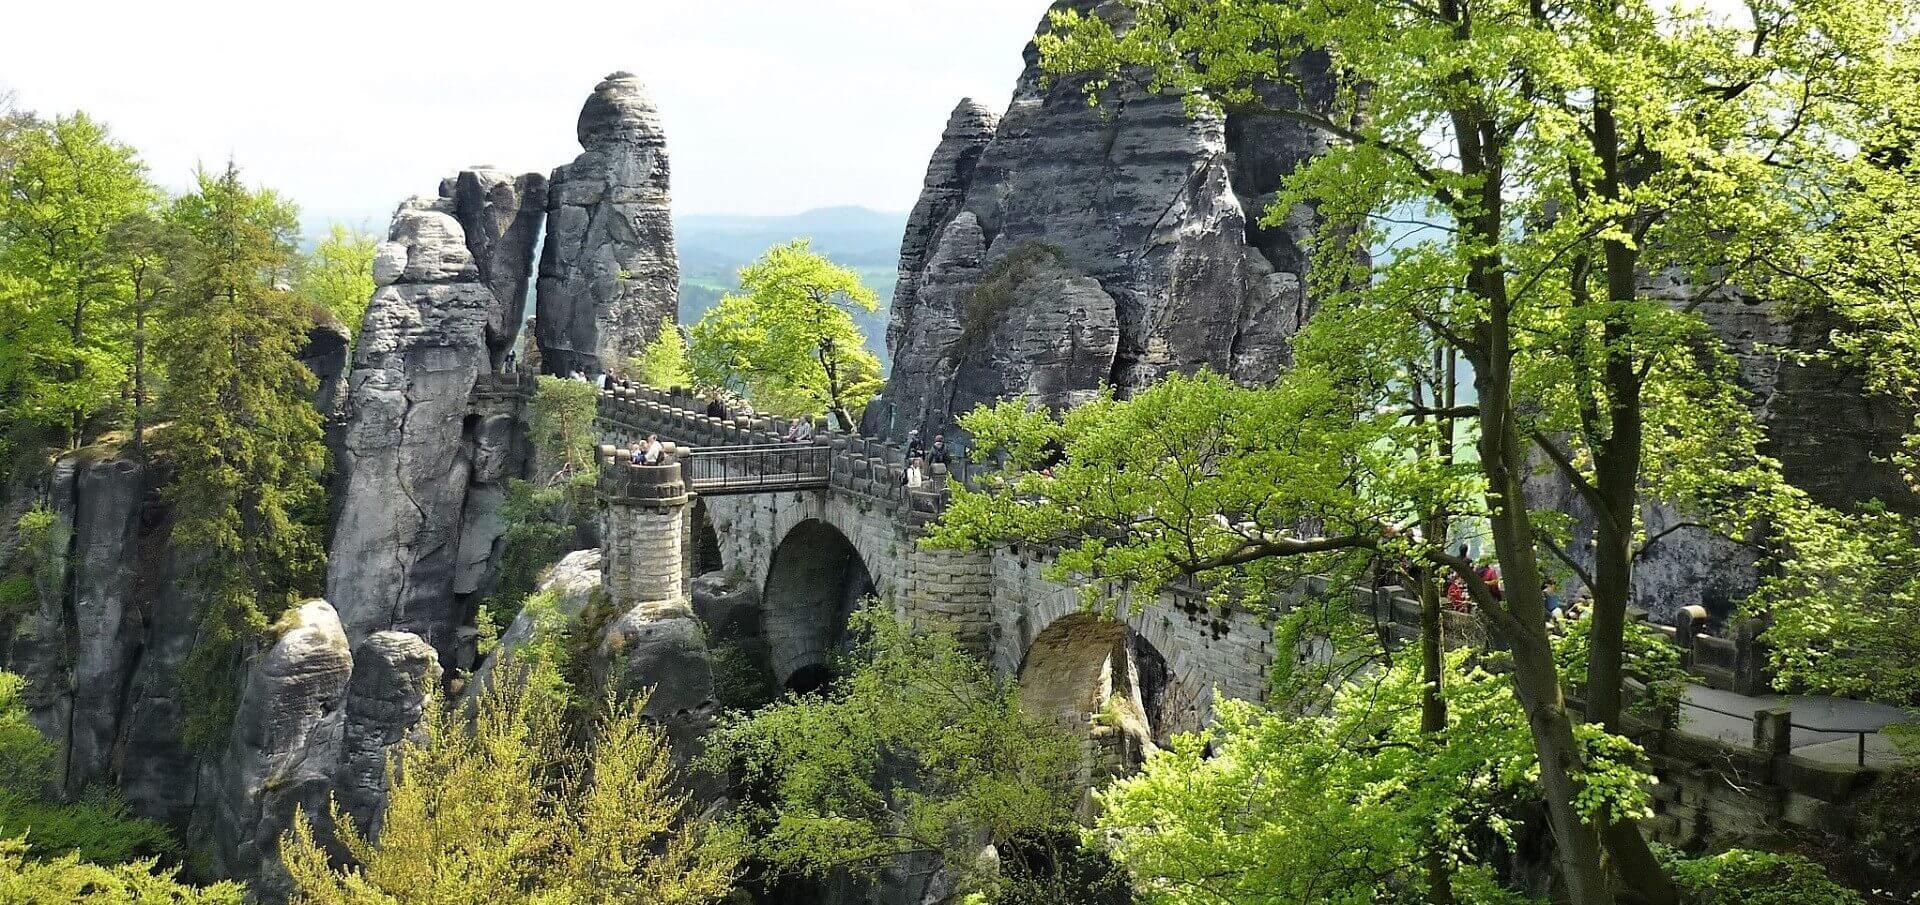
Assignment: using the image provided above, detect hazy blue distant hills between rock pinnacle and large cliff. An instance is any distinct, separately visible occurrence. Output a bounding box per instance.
[674,208,906,367]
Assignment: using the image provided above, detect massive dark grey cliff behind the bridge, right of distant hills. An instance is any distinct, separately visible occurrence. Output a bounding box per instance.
[862,0,1331,440]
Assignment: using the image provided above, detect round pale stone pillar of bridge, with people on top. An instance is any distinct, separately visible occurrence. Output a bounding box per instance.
[599,455,687,611]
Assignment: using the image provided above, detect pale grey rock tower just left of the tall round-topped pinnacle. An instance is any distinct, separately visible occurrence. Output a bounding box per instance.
[326,178,541,669]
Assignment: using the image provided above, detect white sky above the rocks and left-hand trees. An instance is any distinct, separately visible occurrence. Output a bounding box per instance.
[0,0,1048,229]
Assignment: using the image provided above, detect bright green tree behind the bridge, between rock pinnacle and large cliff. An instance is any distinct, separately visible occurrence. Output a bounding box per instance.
[689,240,881,428]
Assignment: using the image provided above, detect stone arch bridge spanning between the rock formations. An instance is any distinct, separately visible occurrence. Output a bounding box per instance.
[583,384,1273,742]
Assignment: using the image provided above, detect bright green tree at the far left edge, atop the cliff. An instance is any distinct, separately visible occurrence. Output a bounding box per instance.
[0,113,156,448]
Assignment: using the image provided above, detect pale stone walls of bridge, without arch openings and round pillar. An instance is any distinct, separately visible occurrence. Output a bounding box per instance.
[601,388,1273,738]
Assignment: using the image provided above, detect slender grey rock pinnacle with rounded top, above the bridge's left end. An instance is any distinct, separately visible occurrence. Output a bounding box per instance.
[534,73,680,375]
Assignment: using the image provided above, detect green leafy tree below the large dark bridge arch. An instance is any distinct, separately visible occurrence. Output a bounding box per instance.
[703,607,1079,901]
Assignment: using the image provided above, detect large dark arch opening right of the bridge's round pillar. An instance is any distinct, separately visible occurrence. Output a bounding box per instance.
[762,519,874,694]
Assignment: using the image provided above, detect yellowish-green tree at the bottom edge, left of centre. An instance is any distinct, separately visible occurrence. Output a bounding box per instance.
[280,669,737,905]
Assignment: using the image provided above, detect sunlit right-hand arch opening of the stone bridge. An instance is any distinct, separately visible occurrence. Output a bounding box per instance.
[1020,613,1173,788]
